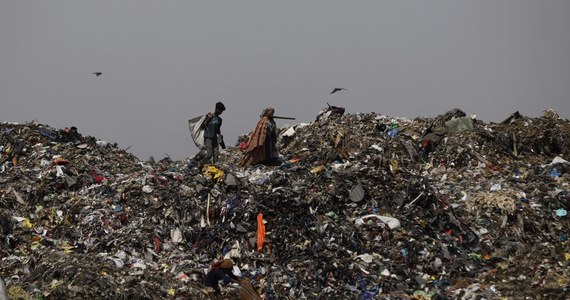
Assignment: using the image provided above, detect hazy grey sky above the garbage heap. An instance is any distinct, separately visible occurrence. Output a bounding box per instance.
[0,0,570,160]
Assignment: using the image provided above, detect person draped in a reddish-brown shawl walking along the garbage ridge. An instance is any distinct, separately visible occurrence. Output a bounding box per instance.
[239,107,279,167]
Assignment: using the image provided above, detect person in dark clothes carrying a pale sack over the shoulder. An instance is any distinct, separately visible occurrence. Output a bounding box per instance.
[203,102,226,164]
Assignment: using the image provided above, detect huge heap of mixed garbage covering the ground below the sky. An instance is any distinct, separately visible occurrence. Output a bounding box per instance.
[0,106,570,299]
